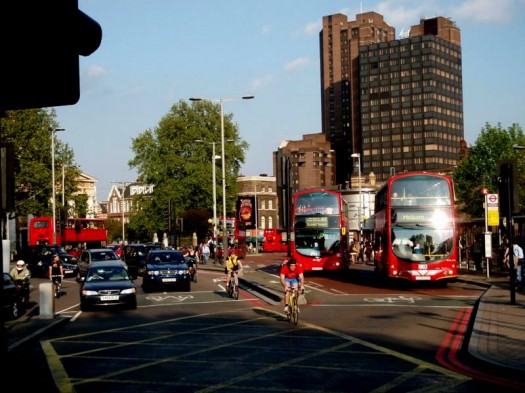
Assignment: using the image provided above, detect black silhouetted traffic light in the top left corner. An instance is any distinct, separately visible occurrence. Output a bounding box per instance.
[0,0,102,111]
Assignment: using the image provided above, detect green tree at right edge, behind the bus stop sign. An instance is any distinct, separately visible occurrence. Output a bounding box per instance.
[453,123,525,218]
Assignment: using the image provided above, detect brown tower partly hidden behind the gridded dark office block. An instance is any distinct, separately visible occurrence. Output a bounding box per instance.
[319,12,395,185]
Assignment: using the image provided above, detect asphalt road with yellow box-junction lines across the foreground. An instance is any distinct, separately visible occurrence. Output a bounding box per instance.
[9,255,508,392]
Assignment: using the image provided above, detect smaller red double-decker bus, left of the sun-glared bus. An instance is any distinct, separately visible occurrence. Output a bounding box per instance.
[290,189,350,272]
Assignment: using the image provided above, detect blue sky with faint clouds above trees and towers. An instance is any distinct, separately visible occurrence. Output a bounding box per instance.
[55,0,525,201]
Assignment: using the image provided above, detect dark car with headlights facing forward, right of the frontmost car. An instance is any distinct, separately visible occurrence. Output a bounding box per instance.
[142,250,191,292]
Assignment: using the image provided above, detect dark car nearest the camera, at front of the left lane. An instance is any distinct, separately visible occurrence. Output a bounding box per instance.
[80,261,137,311]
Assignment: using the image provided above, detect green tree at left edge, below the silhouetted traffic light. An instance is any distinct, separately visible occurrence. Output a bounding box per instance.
[0,109,82,217]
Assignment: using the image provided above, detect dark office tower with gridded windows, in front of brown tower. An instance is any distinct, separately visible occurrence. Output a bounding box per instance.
[359,17,464,182]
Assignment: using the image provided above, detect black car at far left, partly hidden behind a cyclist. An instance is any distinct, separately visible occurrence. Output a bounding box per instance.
[18,244,77,278]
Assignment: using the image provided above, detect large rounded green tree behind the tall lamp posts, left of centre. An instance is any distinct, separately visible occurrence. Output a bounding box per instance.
[129,100,248,237]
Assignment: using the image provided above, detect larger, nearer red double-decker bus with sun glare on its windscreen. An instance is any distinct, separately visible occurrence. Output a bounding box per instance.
[373,172,458,286]
